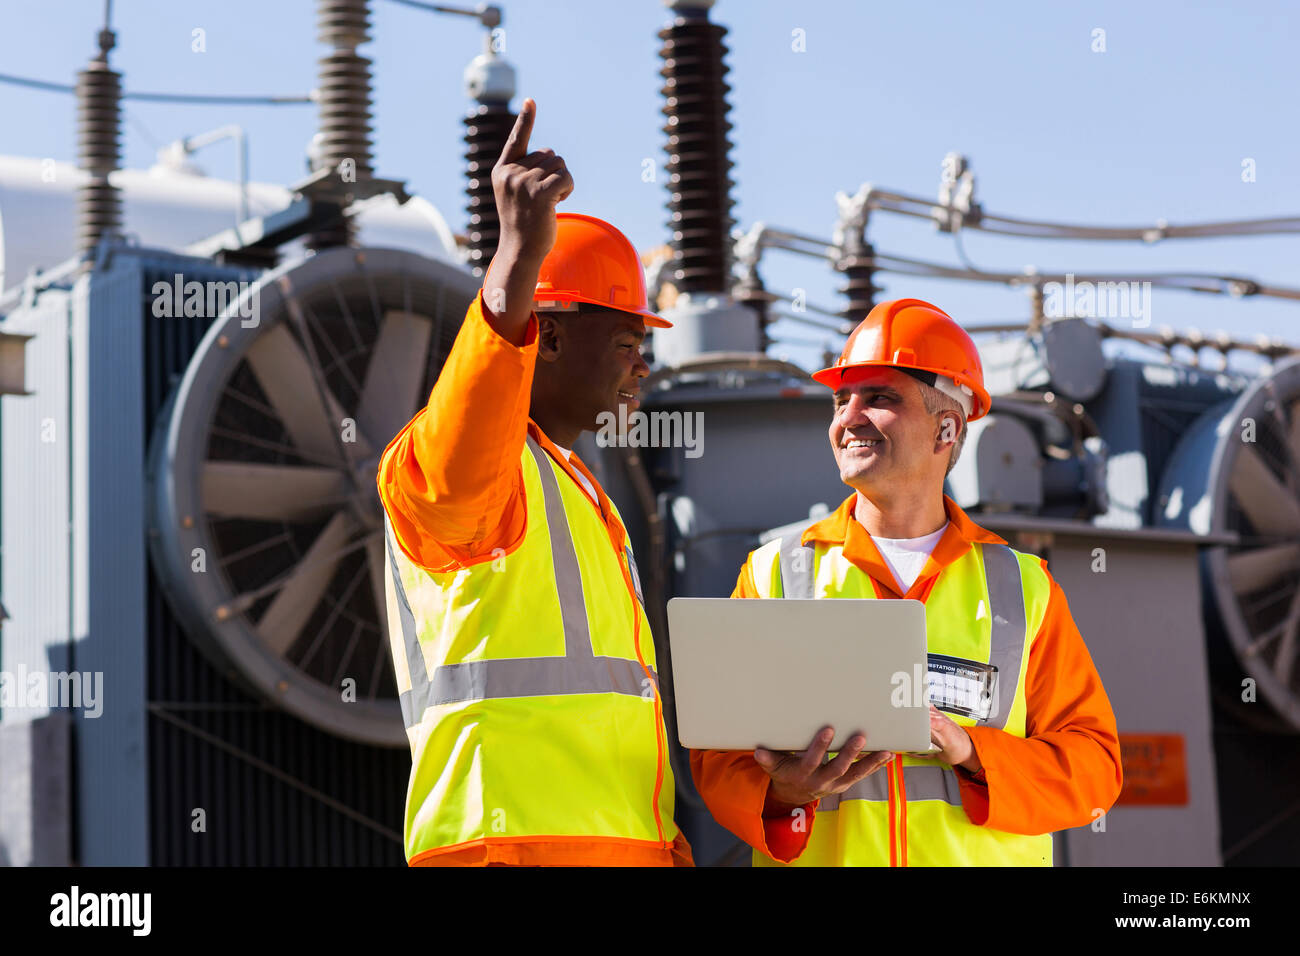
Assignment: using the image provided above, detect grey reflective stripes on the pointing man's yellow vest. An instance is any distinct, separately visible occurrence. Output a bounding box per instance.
[384,436,659,728]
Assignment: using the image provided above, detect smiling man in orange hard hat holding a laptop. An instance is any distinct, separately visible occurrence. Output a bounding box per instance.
[690,299,1122,866]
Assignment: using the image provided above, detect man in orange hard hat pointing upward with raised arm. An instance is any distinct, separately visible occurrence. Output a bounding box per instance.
[378,100,692,866]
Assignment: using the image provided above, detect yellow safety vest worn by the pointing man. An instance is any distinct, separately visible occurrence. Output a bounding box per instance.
[386,436,677,862]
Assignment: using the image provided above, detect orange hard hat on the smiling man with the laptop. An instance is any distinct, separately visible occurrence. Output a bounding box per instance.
[813,299,992,421]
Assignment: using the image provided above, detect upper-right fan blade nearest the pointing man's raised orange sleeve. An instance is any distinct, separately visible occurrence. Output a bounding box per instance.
[356,311,433,447]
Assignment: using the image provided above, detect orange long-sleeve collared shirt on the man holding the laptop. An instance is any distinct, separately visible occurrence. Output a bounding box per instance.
[690,494,1123,862]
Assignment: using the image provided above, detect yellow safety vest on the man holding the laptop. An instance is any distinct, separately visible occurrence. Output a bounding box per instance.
[750,535,1052,866]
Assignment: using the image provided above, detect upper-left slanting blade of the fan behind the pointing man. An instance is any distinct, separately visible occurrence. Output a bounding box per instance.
[246,324,346,462]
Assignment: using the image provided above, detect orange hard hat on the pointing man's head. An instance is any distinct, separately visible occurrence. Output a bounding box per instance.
[533,212,672,329]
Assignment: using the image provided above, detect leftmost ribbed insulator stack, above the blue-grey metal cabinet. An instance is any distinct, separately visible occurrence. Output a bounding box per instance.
[77,30,122,265]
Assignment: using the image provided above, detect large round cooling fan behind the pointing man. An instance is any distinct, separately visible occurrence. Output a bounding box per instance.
[150,247,478,747]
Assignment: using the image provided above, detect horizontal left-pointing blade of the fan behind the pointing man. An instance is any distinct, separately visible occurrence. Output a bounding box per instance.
[203,462,348,522]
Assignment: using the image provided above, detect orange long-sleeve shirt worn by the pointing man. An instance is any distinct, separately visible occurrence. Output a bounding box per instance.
[377,291,693,866]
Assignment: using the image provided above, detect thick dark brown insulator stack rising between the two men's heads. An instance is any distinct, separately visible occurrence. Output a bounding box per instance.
[659,0,735,293]
